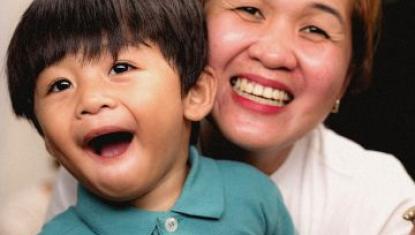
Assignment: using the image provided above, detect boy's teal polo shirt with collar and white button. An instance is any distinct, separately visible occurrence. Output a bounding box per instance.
[41,147,294,235]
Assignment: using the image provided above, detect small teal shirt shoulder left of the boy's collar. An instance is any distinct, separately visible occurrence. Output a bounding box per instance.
[40,207,94,235]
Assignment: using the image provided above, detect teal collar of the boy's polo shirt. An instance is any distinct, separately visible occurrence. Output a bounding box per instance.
[75,147,225,234]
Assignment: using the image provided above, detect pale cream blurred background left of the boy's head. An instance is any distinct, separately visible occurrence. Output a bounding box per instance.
[0,0,53,205]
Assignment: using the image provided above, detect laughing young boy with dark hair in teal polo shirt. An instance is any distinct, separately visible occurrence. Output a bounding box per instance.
[7,0,293,235]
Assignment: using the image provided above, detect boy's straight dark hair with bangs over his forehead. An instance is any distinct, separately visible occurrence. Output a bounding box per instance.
[7,0,207,134]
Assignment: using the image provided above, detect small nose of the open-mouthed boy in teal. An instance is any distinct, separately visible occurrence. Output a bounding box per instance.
[76,83,117,118]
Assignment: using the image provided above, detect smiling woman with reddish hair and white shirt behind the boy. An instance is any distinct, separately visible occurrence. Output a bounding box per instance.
[201,0,415,234]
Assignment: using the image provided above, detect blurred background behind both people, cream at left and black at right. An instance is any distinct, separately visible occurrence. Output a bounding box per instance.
[0,0,415,206]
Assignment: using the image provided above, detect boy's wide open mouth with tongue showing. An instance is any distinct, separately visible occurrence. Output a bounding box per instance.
[87,131,134,158]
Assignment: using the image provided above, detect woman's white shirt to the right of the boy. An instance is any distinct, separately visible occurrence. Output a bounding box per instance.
[271,125,415,235]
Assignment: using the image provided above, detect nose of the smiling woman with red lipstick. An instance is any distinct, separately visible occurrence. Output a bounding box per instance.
[248,25,298,70]
